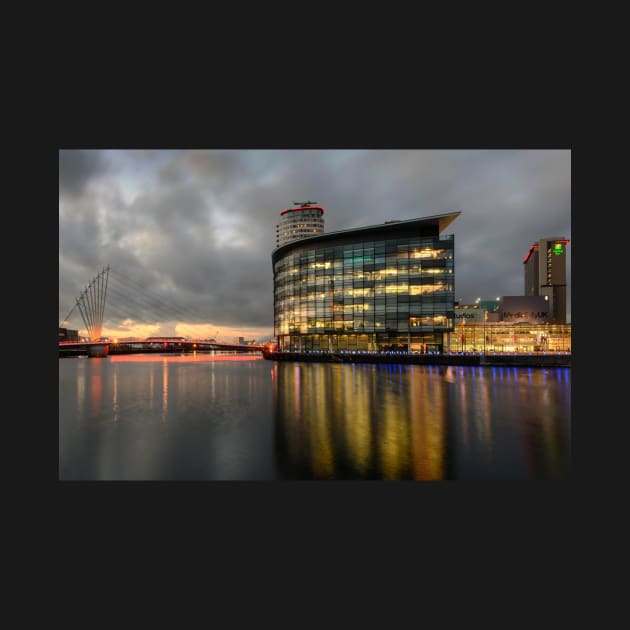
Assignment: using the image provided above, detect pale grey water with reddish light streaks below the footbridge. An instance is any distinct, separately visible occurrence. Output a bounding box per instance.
[59,355,275,480]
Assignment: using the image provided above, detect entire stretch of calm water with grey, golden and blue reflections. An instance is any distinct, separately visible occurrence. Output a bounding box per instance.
[59,354,571,480]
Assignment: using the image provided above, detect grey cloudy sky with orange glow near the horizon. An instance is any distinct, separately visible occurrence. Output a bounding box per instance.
[59,149,572,341]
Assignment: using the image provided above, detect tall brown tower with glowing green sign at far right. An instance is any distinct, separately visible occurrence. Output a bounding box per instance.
[523,237,569,324]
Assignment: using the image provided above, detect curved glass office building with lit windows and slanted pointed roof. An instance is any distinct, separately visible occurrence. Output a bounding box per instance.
[272,212,460,352]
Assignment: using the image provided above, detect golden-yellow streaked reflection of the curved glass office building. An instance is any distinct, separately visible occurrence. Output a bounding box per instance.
[274,363,446,479]
